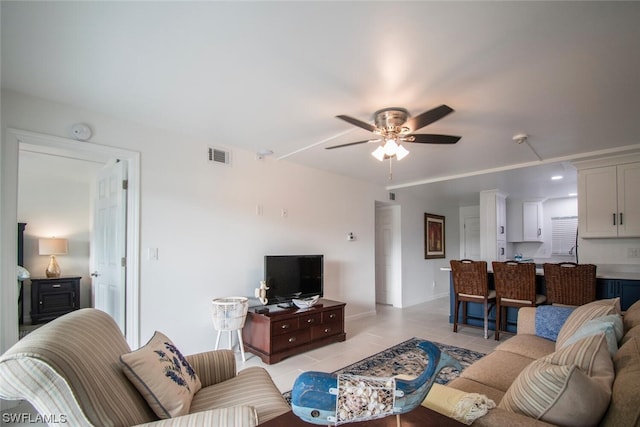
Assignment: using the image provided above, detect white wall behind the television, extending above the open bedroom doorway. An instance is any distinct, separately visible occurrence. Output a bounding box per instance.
[2,92,387,353]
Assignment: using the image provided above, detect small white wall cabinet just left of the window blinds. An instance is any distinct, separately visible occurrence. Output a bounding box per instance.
[507,200,543,242]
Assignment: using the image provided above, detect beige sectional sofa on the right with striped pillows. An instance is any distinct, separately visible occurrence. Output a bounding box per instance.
[448,299,640,427]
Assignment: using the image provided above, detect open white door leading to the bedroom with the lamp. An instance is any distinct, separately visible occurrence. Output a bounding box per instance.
[91,161,127,333]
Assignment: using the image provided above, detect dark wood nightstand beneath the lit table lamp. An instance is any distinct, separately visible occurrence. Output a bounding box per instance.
[31,276,81,324]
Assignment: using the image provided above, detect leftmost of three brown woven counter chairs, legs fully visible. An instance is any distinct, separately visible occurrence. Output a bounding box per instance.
[450,259,496,339]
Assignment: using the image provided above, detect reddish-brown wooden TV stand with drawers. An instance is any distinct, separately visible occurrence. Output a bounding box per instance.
[242,299,347,364]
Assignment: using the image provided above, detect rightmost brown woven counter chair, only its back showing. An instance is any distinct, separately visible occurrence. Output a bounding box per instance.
[542,262,596,306]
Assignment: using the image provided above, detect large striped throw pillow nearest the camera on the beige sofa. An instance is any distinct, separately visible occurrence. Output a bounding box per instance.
[498,333,614,427]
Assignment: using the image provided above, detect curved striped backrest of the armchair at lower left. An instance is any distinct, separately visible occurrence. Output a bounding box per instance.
[0,308,158,426]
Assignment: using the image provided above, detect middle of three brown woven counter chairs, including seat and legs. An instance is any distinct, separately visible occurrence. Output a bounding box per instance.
[492,261,547,341]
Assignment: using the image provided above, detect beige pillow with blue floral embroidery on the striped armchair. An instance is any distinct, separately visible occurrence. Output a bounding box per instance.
[120,331,202,419]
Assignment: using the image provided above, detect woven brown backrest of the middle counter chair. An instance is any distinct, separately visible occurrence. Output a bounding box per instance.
[492,261,536,304]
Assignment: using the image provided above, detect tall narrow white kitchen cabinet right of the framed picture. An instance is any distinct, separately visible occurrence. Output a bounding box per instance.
[480,190,507,263]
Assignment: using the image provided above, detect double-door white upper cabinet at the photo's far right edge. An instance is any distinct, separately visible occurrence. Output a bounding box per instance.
[575,154,640,238]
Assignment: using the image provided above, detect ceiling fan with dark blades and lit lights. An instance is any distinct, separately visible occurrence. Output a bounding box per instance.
[326,104,461,161]
